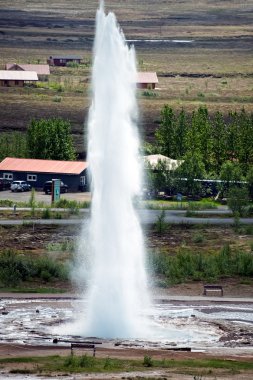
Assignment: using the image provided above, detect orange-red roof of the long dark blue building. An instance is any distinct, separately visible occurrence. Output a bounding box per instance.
[0,157,88,174]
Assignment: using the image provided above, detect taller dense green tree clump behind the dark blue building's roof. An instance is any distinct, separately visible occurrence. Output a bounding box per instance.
[27,118,76,161]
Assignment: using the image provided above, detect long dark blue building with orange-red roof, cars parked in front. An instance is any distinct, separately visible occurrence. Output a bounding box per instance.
[0,157,88,191]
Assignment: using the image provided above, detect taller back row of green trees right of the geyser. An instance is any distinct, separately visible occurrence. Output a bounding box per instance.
[152,105,253,177]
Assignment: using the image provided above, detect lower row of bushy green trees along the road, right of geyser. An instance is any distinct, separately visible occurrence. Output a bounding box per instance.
[146,154,253,199]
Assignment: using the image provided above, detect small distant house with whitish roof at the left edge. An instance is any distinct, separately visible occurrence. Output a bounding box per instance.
[0,70,38,87]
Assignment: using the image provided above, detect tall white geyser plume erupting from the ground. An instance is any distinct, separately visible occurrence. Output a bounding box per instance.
[80,3,148,338]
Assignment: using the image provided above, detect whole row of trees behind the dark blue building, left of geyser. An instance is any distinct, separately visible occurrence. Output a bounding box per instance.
[0,118,76,161]
